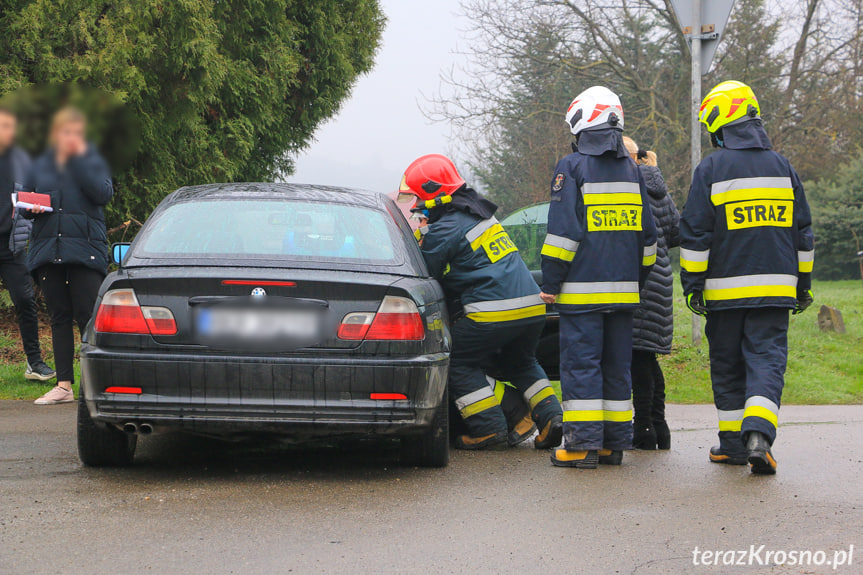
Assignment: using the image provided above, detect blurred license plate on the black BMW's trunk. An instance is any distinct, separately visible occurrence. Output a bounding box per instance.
[198,307,320,340]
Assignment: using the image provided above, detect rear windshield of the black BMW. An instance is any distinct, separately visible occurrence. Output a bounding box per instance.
[135,199,397,265]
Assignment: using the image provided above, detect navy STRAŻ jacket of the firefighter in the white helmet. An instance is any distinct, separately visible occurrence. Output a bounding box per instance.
[542,128,656,313]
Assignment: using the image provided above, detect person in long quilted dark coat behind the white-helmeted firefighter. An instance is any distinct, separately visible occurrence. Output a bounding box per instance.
[623,137,680,449]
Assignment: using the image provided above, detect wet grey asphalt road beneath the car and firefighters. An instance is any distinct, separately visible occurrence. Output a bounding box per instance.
[0,402,863,575]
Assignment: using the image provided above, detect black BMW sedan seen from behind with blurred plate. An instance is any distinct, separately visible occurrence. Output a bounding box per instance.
[78,184,449,467]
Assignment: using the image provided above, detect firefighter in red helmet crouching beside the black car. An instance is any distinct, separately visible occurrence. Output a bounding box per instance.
[399,154,563,449]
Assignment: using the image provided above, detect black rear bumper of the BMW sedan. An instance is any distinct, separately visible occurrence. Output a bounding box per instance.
[81,344,449,437]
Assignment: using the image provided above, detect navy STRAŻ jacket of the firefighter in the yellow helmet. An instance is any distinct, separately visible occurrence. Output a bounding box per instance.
[680,119,815,309]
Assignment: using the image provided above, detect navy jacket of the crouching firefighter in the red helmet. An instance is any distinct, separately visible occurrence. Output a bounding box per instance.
[422,188,545,323]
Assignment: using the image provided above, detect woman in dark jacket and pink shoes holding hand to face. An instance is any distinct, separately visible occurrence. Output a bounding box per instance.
[24,108,114,405]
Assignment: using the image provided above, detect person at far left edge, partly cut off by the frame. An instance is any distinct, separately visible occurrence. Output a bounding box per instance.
[0,108,56,381]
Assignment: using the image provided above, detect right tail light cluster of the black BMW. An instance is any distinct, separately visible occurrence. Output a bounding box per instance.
[338,295,425,341]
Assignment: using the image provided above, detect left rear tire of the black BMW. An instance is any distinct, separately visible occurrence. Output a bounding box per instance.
[78,391,138,467]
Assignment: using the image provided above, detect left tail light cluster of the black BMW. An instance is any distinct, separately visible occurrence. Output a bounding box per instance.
[95,289,177,335]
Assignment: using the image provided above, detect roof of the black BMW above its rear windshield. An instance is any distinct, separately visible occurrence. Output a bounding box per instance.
[164,182,385,207]
